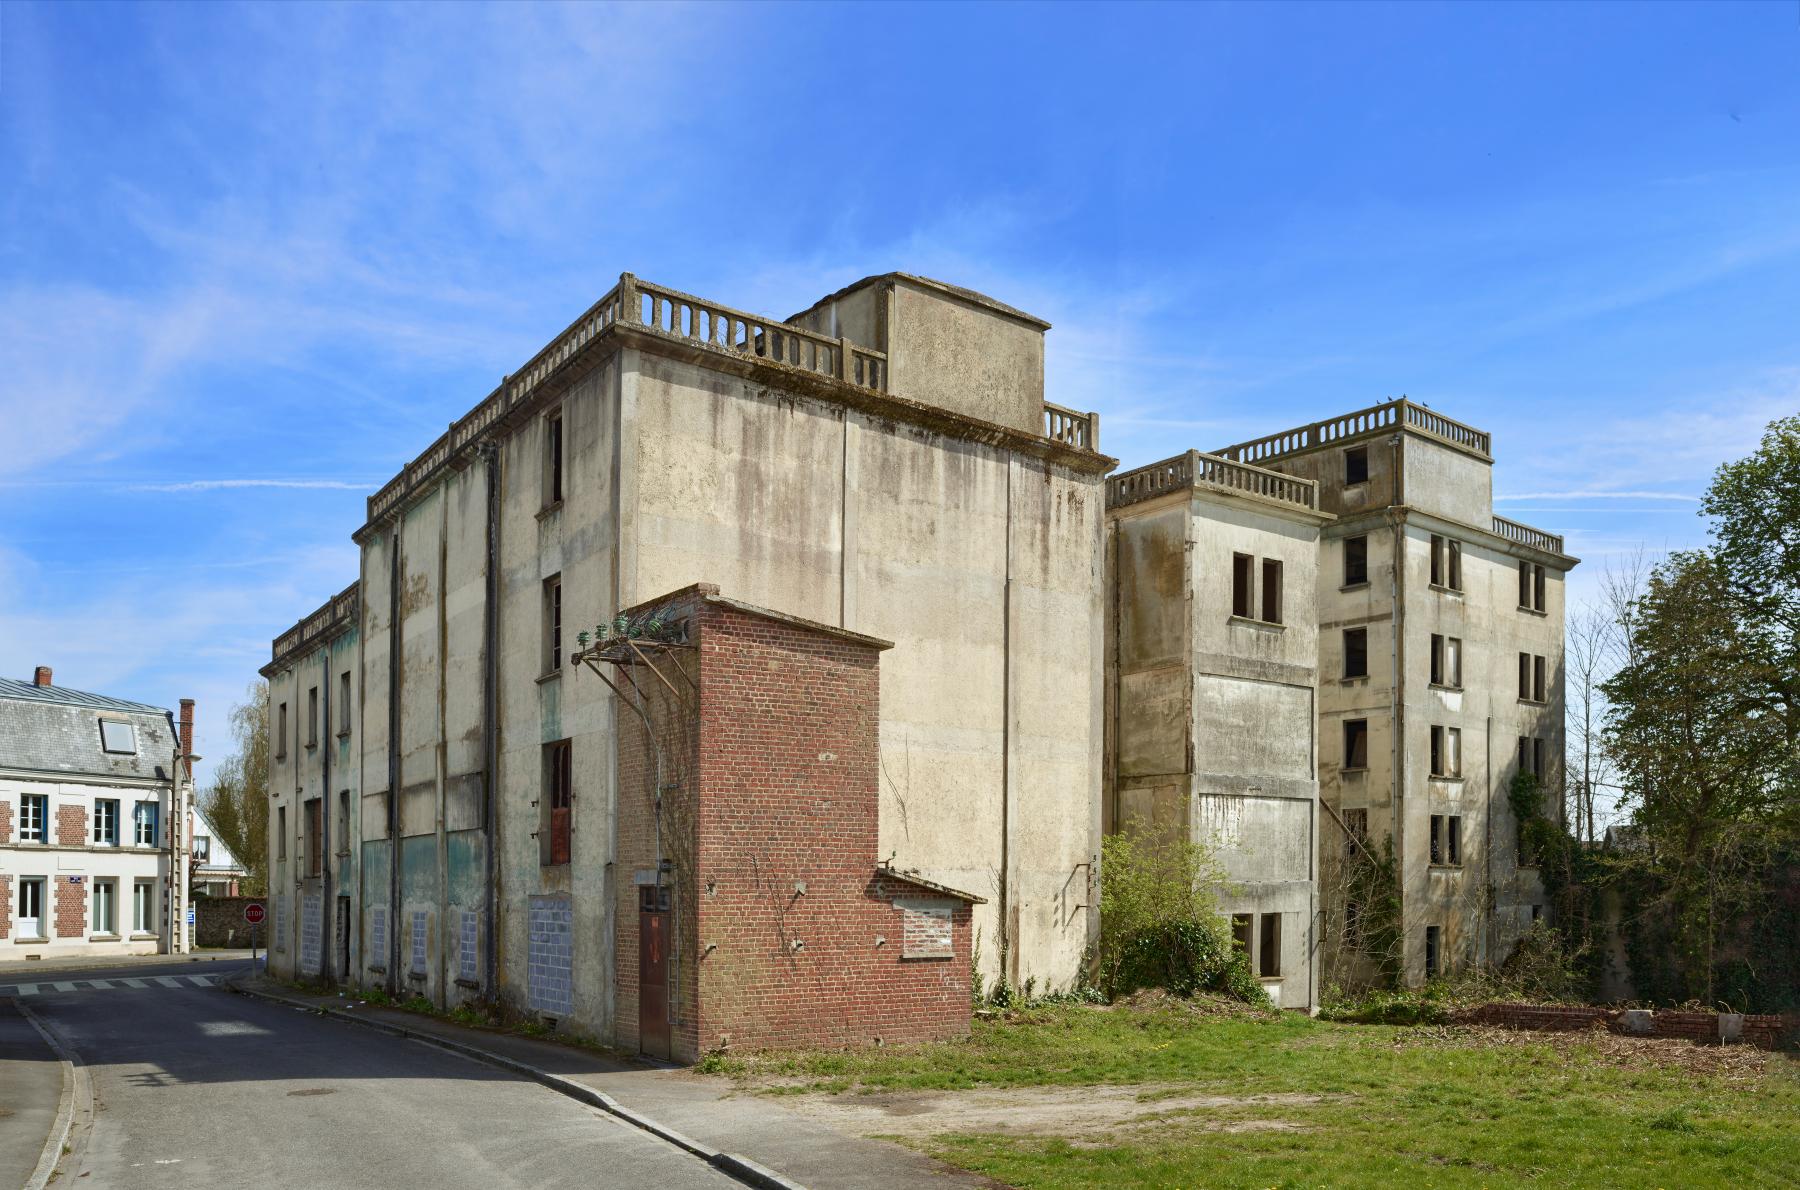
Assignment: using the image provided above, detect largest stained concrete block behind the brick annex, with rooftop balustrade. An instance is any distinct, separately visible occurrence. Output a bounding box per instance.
[265,274,1112,1039]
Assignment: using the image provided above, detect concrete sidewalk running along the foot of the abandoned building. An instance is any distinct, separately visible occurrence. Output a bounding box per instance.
[230,976,997,1190]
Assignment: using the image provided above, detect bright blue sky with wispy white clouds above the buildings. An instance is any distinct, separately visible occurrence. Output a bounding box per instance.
[0,0,1800,784]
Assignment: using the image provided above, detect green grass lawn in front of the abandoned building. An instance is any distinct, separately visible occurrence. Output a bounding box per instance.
[707,1003,1800,1186]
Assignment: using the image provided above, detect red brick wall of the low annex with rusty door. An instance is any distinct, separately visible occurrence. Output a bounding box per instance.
[616,598,970,1059]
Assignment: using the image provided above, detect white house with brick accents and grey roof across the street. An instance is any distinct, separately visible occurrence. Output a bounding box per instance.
[0,666,197,963]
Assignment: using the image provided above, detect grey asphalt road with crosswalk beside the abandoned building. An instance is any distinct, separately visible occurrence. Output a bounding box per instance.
[0,963,738,1190]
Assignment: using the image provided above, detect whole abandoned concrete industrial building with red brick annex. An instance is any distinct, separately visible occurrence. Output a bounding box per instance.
[263,274,1573,1060]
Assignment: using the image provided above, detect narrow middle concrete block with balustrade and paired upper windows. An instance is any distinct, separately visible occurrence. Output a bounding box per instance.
[1105,452,1332,1012]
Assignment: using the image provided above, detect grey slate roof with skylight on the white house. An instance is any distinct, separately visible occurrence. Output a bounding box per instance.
[0,677,175,781]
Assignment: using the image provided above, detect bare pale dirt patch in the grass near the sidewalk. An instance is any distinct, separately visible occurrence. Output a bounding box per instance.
[766,1084,1323,1143]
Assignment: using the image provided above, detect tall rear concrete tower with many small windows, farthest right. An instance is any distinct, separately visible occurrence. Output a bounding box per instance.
[1219,400,1577,985]
